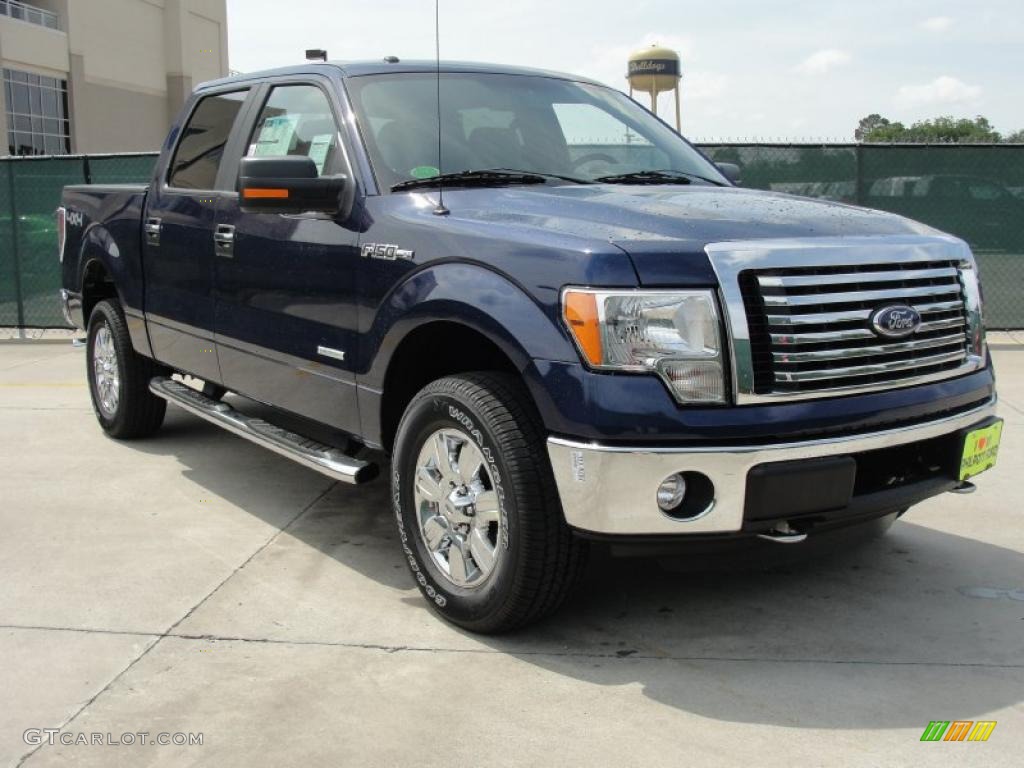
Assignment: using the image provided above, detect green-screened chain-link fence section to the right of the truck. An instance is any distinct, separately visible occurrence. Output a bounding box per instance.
[700,144,1024,329]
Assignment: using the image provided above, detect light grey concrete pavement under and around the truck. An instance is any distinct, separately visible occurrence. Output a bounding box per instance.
[0,342,1024,768]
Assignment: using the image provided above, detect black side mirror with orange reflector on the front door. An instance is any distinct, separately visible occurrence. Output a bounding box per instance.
[239,155,351,213]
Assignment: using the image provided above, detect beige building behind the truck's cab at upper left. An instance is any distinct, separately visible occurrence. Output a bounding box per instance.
[0,0,227,155]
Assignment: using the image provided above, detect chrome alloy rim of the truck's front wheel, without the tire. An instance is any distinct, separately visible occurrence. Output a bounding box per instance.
[413,428,502,589]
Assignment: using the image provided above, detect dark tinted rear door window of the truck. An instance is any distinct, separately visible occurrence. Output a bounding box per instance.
[167,90,249,189]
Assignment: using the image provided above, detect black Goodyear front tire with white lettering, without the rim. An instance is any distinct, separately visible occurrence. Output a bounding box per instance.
[391,373,587,633]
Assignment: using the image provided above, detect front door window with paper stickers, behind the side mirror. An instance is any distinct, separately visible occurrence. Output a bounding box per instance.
[246,85,338,175]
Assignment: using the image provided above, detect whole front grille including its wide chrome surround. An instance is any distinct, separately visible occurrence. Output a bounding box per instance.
[706,236,984,404]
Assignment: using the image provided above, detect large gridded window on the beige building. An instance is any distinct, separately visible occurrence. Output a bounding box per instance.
[3,70,71,155]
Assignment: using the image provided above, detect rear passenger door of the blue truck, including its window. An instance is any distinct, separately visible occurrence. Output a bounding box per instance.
[142,86,250,382]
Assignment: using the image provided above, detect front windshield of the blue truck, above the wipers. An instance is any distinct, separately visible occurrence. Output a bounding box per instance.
[346,73,726,188]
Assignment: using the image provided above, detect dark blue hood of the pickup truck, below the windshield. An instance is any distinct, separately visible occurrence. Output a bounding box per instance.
[445,184,938,285]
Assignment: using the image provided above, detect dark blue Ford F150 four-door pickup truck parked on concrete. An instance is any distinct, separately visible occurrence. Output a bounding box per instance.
[57,58,1001,632]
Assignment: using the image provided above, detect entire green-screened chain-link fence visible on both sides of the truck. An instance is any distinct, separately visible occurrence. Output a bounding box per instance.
[0,143,1024,329]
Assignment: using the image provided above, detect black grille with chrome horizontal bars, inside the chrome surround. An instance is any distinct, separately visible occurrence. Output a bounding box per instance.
[739,261,968,393]
